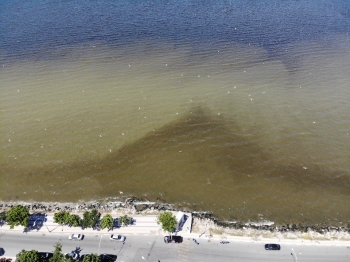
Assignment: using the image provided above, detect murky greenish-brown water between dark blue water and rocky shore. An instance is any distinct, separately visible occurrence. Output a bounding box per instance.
[0,1,350,223]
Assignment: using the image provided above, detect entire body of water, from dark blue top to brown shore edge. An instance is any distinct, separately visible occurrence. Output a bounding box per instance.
[0,0,350,224]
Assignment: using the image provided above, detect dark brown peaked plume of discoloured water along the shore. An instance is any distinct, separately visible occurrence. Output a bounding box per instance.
[3,107,350,223]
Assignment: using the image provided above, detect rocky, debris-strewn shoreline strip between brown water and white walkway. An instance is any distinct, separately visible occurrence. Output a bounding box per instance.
[0,198,350,241]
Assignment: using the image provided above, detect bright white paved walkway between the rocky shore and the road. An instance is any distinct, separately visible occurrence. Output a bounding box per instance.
[0,214,350,262]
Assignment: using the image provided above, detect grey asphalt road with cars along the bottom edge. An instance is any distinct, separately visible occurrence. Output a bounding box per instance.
[0,232,350,262]
